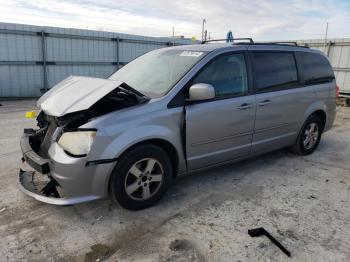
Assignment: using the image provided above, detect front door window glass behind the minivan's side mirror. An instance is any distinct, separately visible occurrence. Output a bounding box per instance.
[192,54,248,98]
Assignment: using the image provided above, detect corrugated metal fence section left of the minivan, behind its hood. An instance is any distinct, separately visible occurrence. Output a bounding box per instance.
[0,23,192,97]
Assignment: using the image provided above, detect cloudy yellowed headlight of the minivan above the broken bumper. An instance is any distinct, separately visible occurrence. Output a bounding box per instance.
[58,130,96,156]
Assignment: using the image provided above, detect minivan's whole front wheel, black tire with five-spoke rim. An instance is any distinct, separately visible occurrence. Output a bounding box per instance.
[110,144,173,210]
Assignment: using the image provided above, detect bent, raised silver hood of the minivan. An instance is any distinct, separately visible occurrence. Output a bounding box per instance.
[37,76,122,117]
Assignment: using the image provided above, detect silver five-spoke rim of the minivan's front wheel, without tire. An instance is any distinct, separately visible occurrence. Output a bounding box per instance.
[124,158,164,201]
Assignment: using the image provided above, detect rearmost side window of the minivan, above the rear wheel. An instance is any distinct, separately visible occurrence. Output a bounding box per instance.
[300,52,334,85]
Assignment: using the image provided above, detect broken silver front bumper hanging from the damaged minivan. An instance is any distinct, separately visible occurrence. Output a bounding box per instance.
[19,133,112,205]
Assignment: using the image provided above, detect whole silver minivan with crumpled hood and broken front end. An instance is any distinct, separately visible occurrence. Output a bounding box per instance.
[19,40,337,210]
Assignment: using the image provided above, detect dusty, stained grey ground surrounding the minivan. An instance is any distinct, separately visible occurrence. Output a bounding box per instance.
[0,101,350,261]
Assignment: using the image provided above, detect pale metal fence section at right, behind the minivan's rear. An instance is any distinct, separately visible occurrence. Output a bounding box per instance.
[297,38,350,97]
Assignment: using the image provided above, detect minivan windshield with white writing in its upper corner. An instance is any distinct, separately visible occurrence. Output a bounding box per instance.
[110,49,205,98]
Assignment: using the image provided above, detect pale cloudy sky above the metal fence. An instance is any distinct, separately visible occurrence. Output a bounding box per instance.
[0,0,350,40]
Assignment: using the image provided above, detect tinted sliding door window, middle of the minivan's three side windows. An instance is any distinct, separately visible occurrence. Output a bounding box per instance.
[253,52,298,93]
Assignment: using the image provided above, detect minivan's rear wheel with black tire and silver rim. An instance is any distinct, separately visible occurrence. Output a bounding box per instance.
[291,115,323,155]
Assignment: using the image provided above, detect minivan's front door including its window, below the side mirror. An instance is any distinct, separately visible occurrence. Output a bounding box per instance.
[186,53,255,170]
